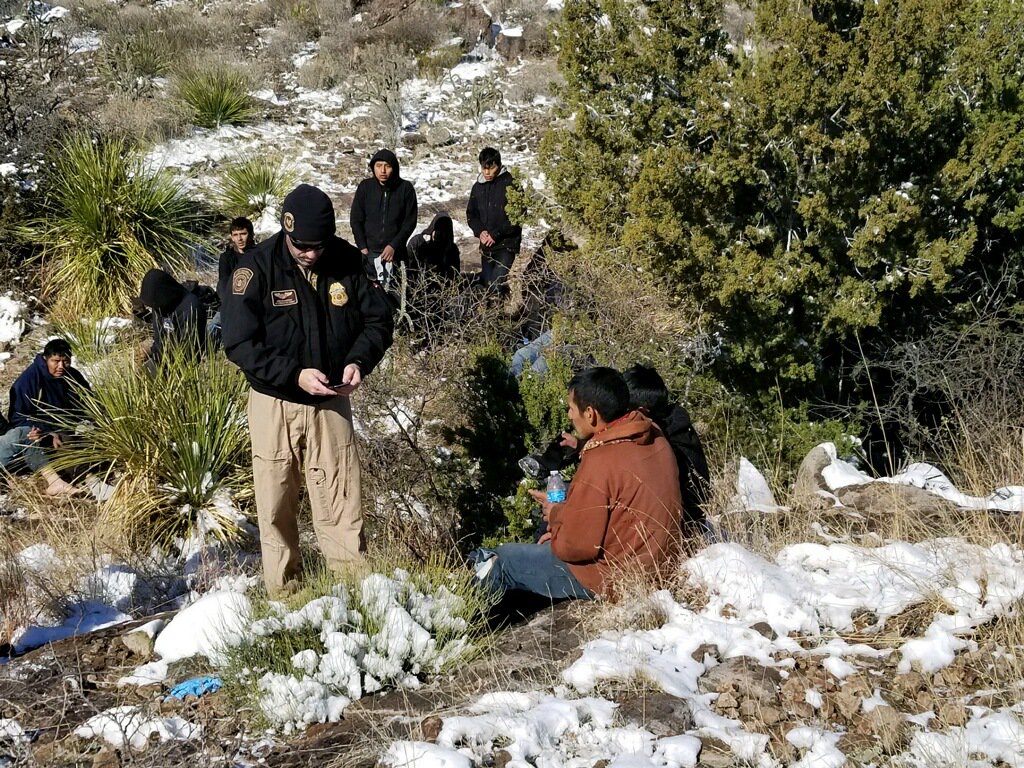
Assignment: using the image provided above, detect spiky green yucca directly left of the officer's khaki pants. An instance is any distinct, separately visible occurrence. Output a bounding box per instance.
[53,345,252,546]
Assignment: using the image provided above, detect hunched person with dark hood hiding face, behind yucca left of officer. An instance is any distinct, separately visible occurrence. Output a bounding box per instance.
[139,269,206,365]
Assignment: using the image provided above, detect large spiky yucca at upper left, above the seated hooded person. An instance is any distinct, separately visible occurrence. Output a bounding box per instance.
[17,135,196,313]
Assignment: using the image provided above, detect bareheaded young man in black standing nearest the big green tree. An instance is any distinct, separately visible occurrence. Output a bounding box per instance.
[466,146,522,293]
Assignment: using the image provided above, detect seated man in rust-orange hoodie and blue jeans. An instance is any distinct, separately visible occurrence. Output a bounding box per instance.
[471,368,682,599]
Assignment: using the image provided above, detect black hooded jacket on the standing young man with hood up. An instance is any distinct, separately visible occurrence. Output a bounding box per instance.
[349,150,419,261]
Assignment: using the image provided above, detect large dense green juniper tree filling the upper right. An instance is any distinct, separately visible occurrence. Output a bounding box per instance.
[543,0,1024,403]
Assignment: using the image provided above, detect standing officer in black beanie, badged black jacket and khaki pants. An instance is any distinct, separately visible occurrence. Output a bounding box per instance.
[223,184,393,593]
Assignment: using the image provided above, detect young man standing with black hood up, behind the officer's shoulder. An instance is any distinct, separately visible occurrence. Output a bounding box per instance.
[349,150,419,290]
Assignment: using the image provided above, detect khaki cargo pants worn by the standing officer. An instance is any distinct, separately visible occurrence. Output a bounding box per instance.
[249,390,366,593]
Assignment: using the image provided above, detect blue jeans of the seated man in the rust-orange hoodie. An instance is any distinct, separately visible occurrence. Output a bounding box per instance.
[471,542,594,600]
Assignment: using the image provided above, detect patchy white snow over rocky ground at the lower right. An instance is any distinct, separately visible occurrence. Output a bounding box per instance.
[382,454,1024,768]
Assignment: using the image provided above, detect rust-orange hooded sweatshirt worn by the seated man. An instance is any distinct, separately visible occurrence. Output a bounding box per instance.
[548,411,682,596]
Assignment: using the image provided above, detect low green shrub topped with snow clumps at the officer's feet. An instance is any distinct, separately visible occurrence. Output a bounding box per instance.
[224,567,486,732]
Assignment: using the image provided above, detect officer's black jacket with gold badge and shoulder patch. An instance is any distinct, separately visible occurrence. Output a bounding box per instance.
[221,232,394,403]
